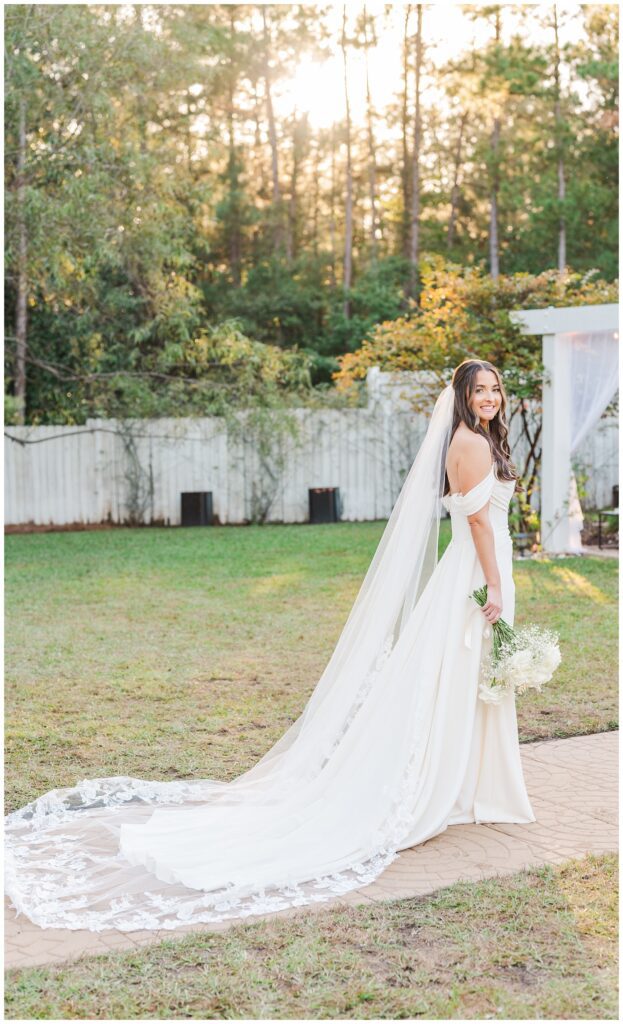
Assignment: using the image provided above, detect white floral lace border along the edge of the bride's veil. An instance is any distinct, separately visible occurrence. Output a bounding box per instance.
[5,618,432,932]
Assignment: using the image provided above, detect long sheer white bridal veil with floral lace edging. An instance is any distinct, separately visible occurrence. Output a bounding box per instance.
[5,386,454,931]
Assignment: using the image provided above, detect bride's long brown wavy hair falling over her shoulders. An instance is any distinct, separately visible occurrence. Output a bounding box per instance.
[444,359,524,494]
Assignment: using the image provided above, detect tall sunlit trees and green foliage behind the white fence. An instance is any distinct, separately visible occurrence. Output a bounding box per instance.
[5,4,618,423]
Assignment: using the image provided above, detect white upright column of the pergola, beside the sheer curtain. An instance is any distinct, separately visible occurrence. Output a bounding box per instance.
[541,334,571,554]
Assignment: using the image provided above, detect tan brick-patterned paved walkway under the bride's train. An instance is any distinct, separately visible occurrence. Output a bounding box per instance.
[5,732,619,968]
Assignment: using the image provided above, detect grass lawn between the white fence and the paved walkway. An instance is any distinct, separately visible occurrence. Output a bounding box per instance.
[5,522,618,810]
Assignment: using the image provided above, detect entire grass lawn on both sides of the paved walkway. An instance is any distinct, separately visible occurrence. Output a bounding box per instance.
[5,523,618,1019]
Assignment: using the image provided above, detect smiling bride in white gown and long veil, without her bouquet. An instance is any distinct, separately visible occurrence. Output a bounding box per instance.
[5,359,535,931]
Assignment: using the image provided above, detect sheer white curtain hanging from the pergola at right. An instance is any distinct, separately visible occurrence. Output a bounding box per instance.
[563,331,619,552]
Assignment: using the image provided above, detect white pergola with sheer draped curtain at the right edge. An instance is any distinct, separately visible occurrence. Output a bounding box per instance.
[509,303,619,554]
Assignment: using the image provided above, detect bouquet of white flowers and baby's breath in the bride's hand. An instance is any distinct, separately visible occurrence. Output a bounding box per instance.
[470,584,560,703]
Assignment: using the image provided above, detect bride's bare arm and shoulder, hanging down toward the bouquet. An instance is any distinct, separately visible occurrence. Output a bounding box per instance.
[457,434,502,623]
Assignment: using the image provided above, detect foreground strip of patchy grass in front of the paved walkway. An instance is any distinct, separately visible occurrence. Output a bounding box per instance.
[5,855,618,1020]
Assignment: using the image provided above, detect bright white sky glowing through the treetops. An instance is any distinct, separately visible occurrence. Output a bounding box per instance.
[275,0,582,127]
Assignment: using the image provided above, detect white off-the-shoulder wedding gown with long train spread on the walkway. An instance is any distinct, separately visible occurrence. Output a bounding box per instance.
[5,466,535,931]
